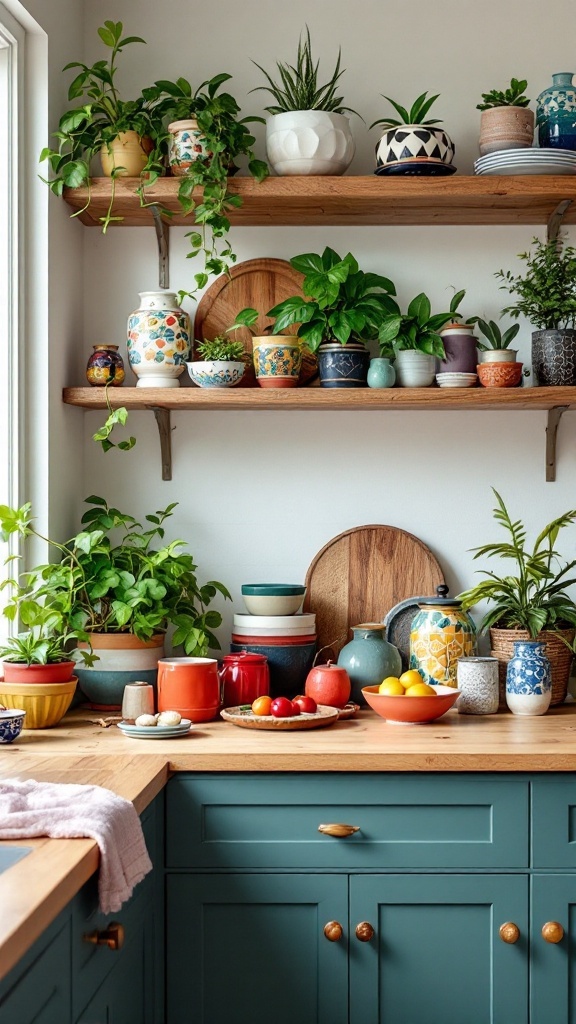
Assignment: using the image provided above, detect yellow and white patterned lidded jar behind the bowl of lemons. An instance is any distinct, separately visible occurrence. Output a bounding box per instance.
[410,585,477,688]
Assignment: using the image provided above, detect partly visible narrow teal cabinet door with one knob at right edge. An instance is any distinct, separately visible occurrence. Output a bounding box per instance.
[530,874,576,1024]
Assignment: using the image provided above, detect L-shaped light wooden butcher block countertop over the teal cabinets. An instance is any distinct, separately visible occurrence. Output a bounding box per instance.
[0,702,576,978]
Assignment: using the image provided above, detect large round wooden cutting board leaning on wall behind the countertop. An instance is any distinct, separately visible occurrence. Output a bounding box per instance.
[303,526,444,660]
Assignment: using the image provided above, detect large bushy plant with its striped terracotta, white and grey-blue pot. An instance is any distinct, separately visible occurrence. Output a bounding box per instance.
[0,495,230,708]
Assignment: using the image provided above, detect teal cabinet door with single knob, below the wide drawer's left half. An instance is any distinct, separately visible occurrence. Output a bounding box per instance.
[166,874,348,1024]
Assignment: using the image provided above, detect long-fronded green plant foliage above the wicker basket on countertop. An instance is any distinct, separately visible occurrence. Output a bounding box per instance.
[459,488,576,638]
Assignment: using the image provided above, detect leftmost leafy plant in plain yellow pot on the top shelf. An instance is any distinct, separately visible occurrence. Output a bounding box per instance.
[40,22,167,231]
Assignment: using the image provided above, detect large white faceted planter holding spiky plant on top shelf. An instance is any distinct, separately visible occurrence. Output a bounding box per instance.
[266,111,356,174]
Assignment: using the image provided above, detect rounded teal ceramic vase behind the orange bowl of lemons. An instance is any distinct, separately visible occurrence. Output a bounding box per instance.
[338,623,402,705]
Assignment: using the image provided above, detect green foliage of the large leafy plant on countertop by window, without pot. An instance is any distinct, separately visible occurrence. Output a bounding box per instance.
[0,495,231,656]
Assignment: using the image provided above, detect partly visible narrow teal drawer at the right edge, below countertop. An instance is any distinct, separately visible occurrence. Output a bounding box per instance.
[532,775,576,868]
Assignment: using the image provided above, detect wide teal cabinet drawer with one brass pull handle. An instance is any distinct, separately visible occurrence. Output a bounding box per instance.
[166,773,529,870]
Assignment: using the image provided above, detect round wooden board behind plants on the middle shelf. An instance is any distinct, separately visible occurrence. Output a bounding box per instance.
[194,257,318,387]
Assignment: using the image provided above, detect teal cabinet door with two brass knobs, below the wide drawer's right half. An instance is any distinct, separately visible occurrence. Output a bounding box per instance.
[349,874,528,1024]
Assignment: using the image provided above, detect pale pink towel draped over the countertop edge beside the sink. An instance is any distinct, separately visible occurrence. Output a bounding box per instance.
[0,779,152,913]
